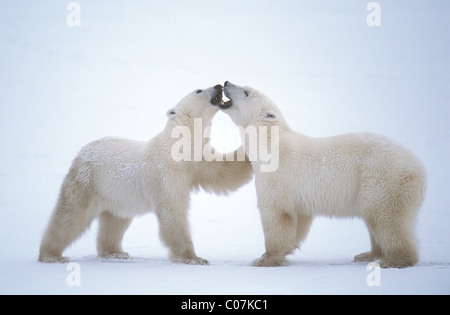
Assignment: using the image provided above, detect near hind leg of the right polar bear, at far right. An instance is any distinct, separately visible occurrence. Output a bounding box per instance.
[355,168,425,268]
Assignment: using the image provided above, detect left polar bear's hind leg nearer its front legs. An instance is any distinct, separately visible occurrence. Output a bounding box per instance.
[97,211,132,259]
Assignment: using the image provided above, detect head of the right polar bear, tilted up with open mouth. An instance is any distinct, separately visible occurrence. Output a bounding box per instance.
[218,81,284,128]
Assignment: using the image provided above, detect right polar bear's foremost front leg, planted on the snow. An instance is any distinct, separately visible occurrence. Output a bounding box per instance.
[253,207,298,267]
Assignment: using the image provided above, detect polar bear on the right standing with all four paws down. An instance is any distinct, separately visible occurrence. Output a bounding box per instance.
[220,82,426,268]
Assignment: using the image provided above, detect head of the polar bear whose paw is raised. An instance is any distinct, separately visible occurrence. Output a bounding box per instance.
[167,84,223,126]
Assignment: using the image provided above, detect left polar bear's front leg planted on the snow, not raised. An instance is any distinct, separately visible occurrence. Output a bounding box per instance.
[156,196,208,265]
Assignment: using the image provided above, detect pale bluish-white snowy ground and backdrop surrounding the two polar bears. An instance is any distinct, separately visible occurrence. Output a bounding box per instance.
[0,0,450,294]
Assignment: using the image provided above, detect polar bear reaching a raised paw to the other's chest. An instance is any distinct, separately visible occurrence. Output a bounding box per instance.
[39,85,253,264]
